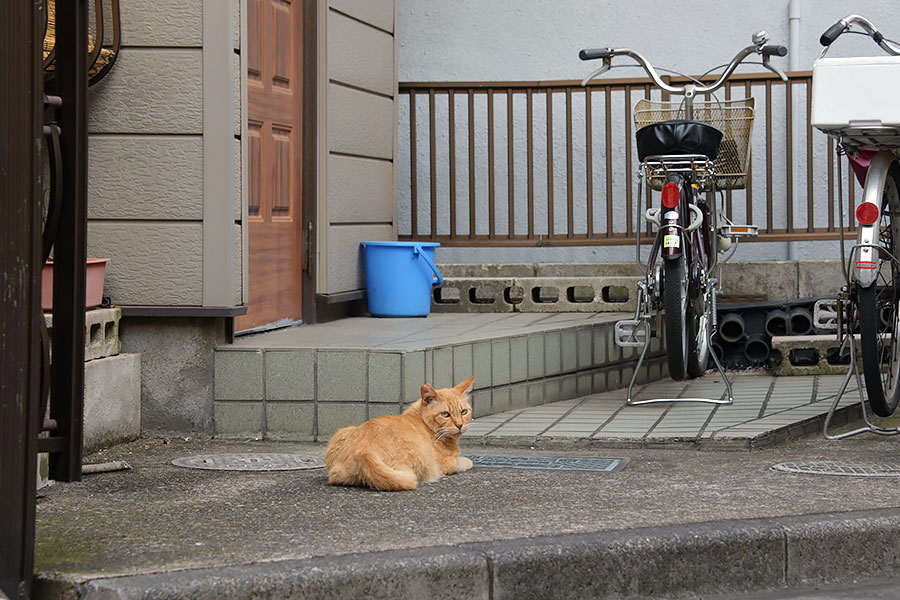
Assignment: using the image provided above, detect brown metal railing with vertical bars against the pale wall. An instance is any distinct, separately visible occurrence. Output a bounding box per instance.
[398,71,860,246]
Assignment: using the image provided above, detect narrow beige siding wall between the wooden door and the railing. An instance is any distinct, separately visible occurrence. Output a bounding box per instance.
[317,0,397,294]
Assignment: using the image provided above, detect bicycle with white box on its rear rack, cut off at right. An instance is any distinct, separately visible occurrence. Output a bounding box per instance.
[811,15,900,439]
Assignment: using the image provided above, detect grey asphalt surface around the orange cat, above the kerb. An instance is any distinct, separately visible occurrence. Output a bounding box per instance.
[36,436,900,580]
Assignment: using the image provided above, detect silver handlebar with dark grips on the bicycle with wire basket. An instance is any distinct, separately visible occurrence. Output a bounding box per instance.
[578,32,787,92]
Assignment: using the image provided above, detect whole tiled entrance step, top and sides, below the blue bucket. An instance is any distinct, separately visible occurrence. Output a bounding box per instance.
[214,313,666,441]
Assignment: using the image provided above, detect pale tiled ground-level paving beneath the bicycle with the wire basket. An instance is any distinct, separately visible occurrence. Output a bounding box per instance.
[465,371,859,449]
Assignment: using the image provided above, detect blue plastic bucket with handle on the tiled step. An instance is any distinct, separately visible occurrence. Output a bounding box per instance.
[362,242,444,317]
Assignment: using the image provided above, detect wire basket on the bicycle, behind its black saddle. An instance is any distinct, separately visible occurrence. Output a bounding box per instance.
[634,98,754,190]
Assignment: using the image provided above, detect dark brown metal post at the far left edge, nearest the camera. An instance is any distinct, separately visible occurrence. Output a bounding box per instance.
[0,2,43,598]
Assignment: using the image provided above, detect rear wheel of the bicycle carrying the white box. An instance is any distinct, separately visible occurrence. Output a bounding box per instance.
[857,163,900,417]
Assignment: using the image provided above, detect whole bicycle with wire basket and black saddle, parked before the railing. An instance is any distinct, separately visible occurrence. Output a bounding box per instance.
[578,31,787,406]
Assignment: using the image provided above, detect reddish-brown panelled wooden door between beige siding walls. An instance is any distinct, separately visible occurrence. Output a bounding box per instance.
[235,0,303,331]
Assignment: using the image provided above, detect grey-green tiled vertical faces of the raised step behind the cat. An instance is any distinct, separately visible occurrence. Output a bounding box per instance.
[209,322,666,441]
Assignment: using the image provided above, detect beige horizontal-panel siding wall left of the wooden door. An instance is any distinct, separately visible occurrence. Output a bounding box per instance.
[88,0,245,306]
